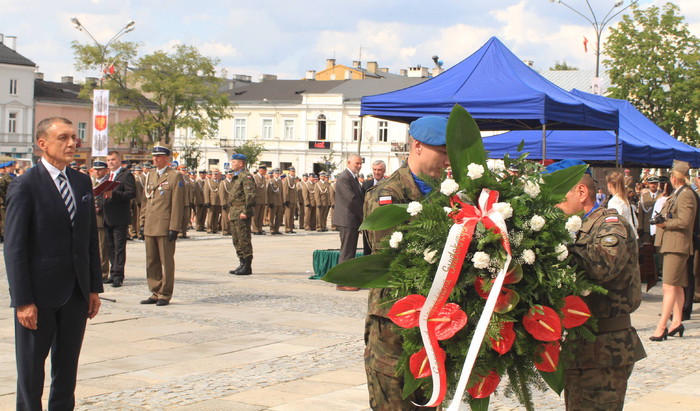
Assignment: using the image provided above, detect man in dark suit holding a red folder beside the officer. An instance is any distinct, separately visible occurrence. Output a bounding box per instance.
[103,151,136,287]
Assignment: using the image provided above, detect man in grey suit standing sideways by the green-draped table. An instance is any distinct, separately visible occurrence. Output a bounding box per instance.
[333,155,364,291]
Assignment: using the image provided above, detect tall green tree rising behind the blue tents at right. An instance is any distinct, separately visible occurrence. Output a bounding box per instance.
[604,3,700,143]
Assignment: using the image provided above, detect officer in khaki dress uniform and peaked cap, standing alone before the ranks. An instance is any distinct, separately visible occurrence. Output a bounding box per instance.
[141,146,185,306]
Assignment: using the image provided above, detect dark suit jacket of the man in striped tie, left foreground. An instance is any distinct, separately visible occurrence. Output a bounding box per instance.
[4,162,103,308]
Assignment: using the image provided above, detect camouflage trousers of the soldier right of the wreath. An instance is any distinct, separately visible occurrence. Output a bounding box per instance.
[564,364,634,411]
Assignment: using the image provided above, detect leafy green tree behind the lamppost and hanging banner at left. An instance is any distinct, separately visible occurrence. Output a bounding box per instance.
[72,41,231,147]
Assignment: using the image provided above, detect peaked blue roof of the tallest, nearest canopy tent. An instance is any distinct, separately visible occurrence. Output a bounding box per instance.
[361,37,618,130]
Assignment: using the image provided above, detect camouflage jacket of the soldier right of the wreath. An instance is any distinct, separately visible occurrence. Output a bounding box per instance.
[569,207,646,368]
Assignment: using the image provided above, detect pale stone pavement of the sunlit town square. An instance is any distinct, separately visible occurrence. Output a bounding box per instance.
[0,231,700,411]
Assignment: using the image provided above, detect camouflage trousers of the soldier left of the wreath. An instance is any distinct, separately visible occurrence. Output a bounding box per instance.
[365,315,435,411]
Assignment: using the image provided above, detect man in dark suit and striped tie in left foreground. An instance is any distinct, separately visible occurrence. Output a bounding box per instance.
[4,117,103,410]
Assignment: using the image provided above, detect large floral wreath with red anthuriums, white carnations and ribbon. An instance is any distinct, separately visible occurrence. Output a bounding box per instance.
[323,106,605,410]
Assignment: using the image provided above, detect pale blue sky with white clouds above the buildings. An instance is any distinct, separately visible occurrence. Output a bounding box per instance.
[0,0,700,81]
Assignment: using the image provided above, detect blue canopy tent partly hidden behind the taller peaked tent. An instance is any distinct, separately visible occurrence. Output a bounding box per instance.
[484,90,700,167]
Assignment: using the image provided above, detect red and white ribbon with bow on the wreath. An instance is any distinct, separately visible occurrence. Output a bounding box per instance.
[417,189,511,411]
